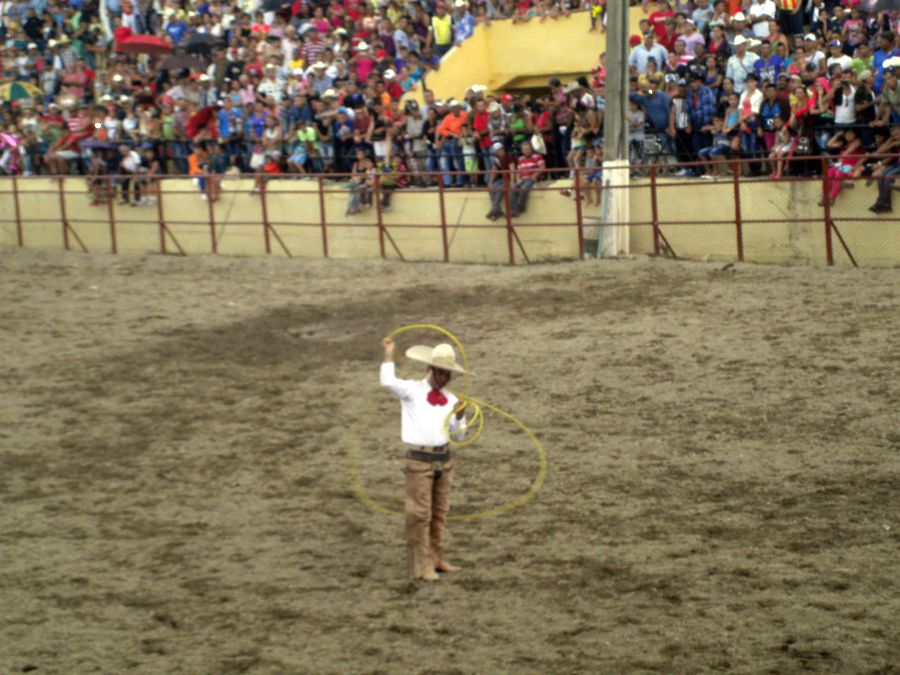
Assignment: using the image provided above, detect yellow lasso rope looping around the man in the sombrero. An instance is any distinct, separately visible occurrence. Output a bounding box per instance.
[347,323,547,521]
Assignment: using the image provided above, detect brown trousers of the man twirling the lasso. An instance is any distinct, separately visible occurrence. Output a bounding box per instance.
[405,459,453,579]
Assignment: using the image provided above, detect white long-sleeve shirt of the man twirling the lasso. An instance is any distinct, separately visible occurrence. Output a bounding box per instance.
[381,362,466,447]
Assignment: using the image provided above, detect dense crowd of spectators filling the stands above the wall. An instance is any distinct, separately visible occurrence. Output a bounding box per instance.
[0,0,900,215]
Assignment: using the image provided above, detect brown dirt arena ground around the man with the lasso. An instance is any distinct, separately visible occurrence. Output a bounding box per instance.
[0,250,900,673]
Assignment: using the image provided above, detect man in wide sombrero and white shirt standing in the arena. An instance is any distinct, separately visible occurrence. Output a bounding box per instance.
[381,337,466,581]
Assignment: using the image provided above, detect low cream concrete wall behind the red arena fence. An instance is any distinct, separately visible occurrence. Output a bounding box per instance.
[0,177,900,266]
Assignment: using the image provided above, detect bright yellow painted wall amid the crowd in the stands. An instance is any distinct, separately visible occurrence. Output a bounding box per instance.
[427,7,647,99]
